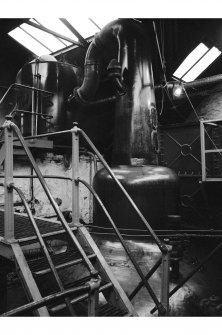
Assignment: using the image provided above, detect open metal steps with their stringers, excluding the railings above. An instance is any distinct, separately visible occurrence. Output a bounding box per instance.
[0,211,135,316]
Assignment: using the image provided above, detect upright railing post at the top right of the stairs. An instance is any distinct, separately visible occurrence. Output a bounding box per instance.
[72,122,79,225]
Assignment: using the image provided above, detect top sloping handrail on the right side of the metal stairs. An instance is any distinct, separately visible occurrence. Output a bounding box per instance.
[78,128,168,254]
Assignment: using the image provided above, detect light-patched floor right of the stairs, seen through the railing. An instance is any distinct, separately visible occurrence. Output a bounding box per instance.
[94,238,222,316]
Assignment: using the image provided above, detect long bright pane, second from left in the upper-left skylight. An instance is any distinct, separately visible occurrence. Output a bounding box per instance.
[20,23,64,52]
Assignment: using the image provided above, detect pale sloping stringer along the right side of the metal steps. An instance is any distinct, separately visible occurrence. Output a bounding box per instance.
[77,226,138,316]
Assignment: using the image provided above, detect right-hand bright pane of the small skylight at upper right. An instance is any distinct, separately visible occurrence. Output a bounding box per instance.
[183,47,221,82]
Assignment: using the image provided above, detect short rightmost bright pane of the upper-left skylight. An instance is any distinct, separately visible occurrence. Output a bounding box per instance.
[66,17,99,38]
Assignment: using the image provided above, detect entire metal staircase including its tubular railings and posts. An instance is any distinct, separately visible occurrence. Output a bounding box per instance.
[0,117,170,316]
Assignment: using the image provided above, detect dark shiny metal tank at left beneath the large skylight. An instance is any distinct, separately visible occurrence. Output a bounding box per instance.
[16,56,78,135]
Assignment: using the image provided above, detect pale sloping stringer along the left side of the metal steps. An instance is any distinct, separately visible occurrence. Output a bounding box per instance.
[11,242,50,316]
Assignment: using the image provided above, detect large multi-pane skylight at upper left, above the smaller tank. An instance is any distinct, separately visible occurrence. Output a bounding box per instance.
[8,17,117,56]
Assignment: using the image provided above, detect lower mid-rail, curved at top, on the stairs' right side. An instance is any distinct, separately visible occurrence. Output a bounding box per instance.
[78,178,166,314]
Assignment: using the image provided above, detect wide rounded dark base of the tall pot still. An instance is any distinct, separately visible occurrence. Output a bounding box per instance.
[94,165,179,229]
